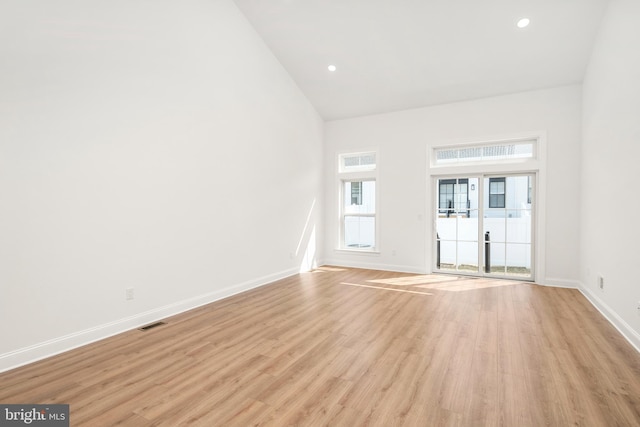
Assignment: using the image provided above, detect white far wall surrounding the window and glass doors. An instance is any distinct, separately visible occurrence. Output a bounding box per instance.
[324,86,581,286]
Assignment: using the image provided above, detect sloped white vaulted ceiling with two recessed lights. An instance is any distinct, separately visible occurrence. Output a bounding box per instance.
[235,0,608,120]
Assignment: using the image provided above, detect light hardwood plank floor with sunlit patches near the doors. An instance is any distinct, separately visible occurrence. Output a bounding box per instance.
[0,267,640,427]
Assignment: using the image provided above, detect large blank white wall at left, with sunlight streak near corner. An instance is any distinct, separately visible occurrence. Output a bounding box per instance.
[0,0,323,370]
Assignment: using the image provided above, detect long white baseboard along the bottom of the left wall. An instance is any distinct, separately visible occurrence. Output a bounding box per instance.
[0,268,299,372]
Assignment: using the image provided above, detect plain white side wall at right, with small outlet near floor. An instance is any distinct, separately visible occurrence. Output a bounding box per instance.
[580,0,640,349]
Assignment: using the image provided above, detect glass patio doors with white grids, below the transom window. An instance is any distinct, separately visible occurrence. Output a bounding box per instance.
[435,174,535,280]
